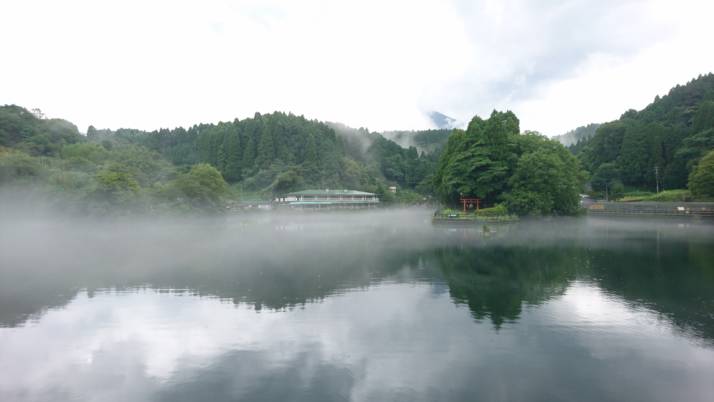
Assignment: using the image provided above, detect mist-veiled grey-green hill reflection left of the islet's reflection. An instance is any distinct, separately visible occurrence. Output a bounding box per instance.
[0,213,434,326]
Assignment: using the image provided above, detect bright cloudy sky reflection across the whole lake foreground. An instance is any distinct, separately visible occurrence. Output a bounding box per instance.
[0,282,714,401]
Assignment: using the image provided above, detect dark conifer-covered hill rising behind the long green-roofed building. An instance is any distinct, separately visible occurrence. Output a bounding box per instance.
[87,112,430,196]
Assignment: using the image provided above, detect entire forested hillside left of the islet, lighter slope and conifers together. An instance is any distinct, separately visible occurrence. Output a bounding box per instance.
[0,105,436,211]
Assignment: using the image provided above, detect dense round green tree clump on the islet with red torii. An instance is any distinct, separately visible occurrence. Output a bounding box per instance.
[434,111,584,214]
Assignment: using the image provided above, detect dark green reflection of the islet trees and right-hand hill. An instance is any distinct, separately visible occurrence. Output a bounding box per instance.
[434,240,714,341]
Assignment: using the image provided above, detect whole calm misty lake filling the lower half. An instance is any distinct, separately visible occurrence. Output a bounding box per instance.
[0,209,714,402]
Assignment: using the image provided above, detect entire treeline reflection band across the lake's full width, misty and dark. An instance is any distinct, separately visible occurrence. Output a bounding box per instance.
[0,211,714,340]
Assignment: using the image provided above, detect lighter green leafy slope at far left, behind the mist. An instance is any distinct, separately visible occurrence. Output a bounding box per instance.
[0,106,228,215]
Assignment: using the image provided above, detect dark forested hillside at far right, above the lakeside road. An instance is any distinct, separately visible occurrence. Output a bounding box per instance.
[578,74,714,191]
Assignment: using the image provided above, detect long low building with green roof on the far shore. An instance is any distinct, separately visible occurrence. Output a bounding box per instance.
[275,190,379,209]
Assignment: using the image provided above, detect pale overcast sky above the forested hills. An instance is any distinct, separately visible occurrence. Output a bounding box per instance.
[0,0,714,135]
